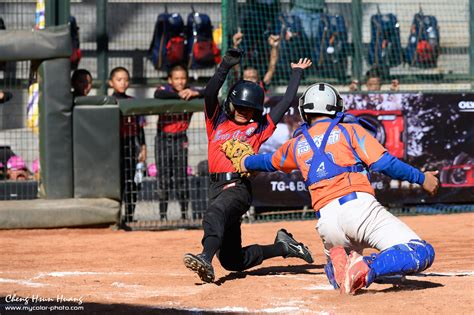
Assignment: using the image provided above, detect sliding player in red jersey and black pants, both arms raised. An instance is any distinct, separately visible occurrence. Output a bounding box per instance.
[183,49,313,282]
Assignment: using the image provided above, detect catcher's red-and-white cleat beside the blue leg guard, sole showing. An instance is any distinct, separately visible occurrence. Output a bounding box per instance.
[341,251,370,294]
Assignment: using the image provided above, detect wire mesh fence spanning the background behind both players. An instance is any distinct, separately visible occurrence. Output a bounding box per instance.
[0,0,474,229]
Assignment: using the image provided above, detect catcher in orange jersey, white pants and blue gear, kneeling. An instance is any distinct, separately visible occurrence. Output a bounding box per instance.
[226,83,439,293]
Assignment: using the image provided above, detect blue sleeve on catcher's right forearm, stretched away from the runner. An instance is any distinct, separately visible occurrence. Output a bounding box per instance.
[370,152,425,185]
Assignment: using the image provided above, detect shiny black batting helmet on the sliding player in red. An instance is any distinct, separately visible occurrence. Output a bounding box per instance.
[224,80,265,118]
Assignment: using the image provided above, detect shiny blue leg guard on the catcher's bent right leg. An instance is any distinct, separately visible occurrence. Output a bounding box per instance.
[364,240,435,286]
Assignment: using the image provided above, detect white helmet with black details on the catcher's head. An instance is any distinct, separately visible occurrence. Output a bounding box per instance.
[299,83,344,122]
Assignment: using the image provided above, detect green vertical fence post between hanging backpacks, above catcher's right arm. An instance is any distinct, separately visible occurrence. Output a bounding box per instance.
[352,0,363,82]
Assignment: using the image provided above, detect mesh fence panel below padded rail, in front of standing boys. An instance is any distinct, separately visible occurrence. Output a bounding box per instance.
[122,112,209,228]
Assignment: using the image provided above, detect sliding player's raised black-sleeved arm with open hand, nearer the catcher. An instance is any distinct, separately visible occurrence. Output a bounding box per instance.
[270,58,313,124]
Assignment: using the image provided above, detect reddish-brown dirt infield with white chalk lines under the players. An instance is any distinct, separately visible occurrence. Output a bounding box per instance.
[0,213,474,314]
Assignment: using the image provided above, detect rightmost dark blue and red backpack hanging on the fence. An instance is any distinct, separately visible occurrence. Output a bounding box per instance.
[405,9,440,68]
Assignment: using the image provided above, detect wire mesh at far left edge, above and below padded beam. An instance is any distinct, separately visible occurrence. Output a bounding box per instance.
[0,2,39,200]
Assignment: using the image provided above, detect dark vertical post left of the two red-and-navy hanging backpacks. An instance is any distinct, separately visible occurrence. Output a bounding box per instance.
[96,0,109,95]
